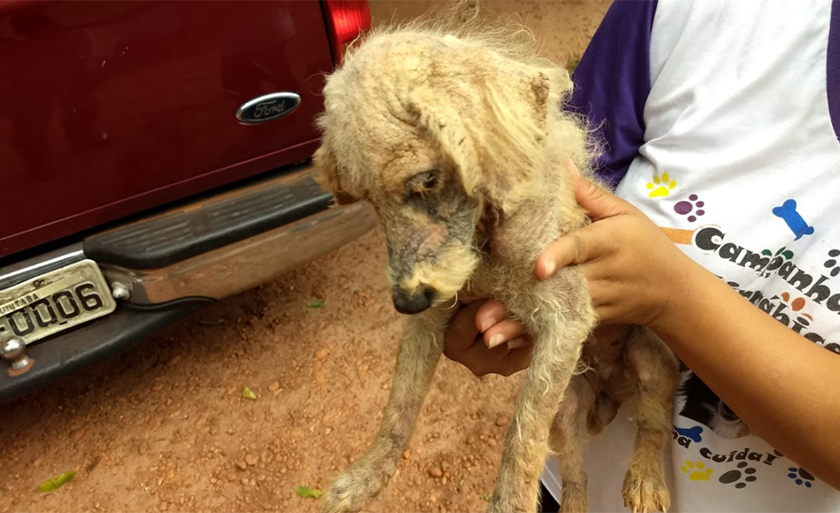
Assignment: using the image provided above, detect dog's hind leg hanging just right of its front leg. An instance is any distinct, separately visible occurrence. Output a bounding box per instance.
[549,375,595,513]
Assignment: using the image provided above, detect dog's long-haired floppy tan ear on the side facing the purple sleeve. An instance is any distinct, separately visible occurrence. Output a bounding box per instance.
[405,58,571,212]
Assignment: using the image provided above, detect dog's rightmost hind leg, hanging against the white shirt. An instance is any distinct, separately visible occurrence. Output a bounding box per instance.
[622,330,679,513]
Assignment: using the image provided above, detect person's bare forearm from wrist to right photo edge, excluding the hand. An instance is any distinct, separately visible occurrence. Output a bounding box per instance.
[649,246,840,489]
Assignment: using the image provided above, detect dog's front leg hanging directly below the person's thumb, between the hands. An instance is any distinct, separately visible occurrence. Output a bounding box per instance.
[487,270,595,513]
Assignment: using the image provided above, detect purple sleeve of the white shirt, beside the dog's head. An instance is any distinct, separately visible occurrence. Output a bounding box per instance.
[566,0,657,187]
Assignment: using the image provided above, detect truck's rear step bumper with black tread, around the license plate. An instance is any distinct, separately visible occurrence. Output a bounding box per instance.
[0,166,377,402]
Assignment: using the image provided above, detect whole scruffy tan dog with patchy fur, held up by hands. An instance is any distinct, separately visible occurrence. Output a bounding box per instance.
[315,9,678,513]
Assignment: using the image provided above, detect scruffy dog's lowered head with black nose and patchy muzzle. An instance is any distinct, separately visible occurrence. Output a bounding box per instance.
[315,31,571,313]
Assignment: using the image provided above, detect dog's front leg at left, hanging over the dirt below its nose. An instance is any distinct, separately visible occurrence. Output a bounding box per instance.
[321,308,451,513]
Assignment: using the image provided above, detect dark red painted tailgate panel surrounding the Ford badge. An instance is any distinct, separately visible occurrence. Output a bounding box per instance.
[0,0,332,258]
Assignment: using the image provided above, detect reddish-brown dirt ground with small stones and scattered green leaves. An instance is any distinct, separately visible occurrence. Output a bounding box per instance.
[0,0,609,513]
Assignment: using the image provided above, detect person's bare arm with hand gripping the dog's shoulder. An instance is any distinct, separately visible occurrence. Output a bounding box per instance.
[452,170,840,489]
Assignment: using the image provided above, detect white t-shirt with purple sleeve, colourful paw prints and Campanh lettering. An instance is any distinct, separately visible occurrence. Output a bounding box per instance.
[543,0,840,512]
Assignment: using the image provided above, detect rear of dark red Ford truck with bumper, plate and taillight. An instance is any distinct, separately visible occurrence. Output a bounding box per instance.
[0,0,376,402]
